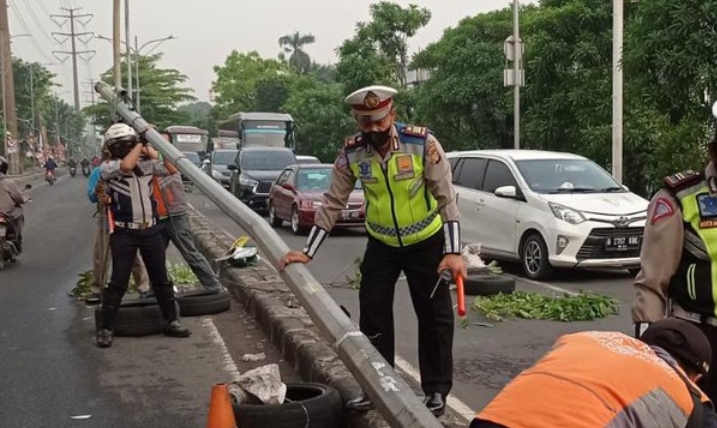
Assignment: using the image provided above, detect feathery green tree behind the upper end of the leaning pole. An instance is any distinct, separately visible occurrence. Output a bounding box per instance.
[85,54,195,128]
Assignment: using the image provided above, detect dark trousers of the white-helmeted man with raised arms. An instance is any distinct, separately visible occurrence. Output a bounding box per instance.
[101,225,179,330]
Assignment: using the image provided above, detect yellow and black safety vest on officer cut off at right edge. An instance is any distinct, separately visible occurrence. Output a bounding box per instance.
[669,183,717,316]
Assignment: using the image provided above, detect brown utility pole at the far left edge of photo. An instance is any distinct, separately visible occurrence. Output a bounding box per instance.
[0,0,18,168]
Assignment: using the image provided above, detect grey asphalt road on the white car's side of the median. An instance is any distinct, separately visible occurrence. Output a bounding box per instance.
[190,193,633,422]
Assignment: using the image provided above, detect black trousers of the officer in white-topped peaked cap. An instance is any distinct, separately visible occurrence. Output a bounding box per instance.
[359,231,453,397]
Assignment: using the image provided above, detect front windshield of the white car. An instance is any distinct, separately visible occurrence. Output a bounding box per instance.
[515,159,625,193]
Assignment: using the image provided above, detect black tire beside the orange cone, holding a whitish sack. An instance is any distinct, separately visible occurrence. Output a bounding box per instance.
[232,383,345,428]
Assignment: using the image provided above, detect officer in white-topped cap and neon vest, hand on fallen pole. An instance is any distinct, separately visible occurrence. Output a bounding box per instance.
[279,86,466,416]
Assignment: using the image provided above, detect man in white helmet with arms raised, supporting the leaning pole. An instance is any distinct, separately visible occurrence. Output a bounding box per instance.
[97,123,190,348]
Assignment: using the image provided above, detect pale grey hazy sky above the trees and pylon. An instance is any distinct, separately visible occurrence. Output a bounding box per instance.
[7,0,526,106]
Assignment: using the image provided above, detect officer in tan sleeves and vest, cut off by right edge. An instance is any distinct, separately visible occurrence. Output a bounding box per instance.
[632,123,717,401]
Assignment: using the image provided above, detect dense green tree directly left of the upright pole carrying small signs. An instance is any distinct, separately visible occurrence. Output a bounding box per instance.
[411,9,512,150]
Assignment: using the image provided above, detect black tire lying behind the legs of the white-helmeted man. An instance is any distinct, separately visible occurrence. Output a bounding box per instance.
[95,299,178,337]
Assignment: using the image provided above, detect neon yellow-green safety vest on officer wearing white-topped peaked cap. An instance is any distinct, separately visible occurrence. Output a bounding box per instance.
[347,124,443,247]
